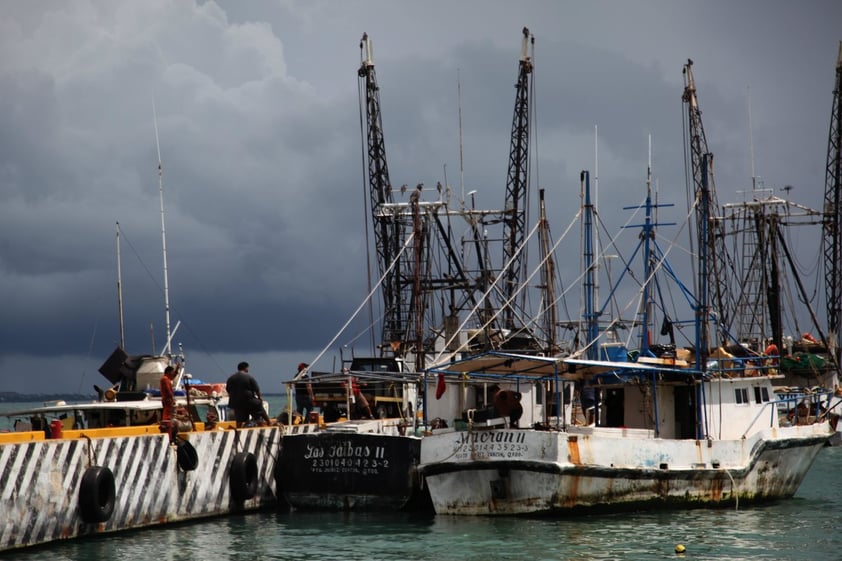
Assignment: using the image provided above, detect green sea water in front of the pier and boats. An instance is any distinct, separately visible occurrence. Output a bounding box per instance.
[0,399,842,561]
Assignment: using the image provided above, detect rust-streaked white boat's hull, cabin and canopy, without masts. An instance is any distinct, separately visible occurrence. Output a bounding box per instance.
[420,354,830,515]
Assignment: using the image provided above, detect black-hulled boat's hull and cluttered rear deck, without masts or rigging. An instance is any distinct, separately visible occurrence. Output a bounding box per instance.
[276,359,425,512]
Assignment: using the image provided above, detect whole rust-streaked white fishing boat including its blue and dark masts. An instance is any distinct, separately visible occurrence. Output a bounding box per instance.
[419,62,832,515]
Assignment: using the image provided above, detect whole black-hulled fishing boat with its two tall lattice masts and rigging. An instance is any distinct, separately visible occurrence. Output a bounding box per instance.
[276,29,534,511]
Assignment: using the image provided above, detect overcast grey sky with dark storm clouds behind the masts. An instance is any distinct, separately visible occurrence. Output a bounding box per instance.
[0,0,842,393]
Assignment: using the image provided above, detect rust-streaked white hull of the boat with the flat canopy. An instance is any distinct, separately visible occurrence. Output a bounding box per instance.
[421,425,828,515]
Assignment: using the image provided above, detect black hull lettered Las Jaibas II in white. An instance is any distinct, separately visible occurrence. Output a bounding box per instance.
[276,431,429,512]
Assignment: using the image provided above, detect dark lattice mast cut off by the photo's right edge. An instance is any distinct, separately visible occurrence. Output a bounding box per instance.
[823,41,842,368]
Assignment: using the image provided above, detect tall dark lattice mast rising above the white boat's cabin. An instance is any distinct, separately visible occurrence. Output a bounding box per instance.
[682,59,733,358]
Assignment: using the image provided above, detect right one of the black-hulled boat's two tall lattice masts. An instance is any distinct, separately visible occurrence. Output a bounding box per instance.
[503,27,535,329]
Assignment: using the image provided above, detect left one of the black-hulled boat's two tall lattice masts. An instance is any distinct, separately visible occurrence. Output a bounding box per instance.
[357,33,412,347]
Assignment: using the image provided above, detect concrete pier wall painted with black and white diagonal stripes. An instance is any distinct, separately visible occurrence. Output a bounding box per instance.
[0,427,281,550]
